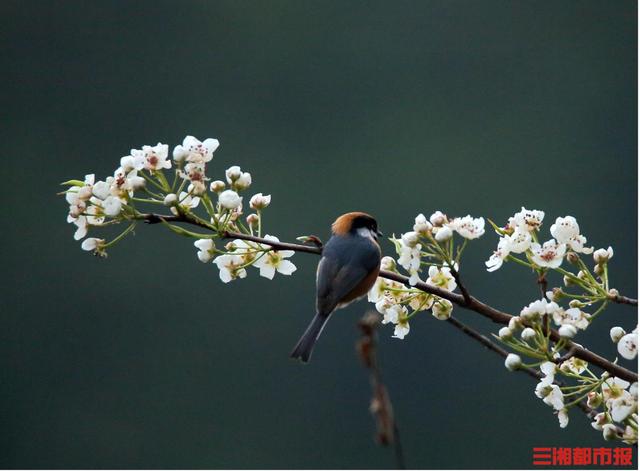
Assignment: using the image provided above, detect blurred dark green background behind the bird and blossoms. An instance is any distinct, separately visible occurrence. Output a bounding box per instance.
[0,1,637,468]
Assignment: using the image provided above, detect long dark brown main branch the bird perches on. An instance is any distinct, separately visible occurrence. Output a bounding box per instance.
[137,214,638,383]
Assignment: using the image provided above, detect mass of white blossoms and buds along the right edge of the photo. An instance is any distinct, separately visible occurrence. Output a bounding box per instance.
[486,208,638,443]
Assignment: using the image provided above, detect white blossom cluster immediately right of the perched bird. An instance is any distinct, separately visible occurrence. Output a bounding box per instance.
[368,211,484,339]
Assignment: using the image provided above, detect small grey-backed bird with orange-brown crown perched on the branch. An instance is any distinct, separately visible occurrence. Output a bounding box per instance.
[291,212,382,363]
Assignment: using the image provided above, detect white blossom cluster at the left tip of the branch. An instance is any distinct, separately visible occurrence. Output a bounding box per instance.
[64,136,296,282]
